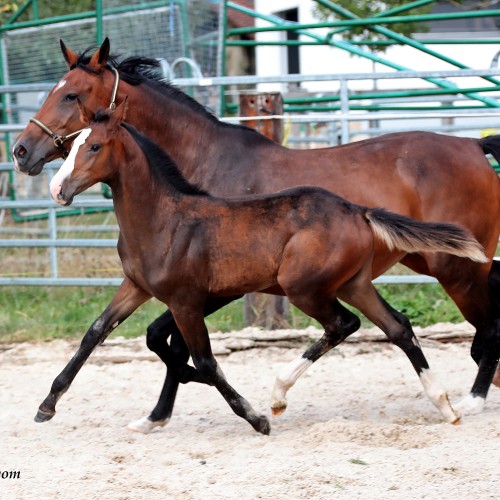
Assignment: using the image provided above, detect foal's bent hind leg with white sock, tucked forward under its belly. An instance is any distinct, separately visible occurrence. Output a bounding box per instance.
[271,297,360,416]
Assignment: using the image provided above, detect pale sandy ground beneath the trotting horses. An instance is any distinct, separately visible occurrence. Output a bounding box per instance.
[0,322,500,500]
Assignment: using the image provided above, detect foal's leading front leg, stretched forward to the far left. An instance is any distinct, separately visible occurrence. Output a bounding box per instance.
[35,278,151,422]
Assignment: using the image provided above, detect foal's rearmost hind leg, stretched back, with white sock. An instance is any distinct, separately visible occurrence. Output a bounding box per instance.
[339,279,460,423]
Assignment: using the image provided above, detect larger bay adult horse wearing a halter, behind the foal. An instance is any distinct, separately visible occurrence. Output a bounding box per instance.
[13,39,500,427]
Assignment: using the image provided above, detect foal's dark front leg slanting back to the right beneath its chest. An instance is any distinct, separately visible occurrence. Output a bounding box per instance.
[170,303,271,434]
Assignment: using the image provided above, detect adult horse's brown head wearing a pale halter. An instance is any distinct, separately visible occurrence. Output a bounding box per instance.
[12,38,117,175]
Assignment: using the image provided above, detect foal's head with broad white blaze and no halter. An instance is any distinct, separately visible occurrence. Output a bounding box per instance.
[50,100,127,205]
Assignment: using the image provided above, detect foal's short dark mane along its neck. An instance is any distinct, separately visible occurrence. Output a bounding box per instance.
[94,110,209,196]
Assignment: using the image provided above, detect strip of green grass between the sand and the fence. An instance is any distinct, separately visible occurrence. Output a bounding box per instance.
[0,285,463,342]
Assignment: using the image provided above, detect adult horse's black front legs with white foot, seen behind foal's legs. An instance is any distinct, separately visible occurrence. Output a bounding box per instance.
[127,297,239,434]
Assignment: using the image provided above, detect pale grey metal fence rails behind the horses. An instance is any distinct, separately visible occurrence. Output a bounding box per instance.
[0,68,500,286]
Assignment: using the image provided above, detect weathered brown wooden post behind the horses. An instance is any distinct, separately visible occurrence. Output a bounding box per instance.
[240,92,290,330]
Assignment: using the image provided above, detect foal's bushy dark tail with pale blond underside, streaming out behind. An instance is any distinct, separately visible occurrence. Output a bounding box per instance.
[364,208,489,262]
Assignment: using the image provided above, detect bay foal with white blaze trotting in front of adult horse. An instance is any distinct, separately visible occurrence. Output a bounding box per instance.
[36,101,488,434]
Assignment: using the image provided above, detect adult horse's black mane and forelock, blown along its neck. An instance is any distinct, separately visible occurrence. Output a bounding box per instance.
[70,47,263,137]
